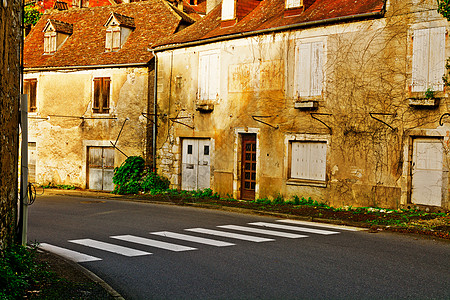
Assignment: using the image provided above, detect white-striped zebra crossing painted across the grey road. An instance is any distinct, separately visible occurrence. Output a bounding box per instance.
[39,219,358,263]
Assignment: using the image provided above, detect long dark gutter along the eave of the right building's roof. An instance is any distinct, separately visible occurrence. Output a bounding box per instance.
[152,7,385,53]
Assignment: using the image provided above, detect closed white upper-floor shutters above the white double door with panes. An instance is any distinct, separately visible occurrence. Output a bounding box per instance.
[198,51,220,100]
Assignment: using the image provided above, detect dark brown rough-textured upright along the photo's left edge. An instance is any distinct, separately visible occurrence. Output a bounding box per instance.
[0,0,22,248]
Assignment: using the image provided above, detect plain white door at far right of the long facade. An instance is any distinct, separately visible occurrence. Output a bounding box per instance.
[411,138,444,206]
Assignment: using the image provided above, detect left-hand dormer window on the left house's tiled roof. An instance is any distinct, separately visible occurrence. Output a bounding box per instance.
[43,20,73,54]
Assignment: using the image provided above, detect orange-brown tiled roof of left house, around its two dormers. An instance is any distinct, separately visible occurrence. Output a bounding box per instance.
[24,0,192,68]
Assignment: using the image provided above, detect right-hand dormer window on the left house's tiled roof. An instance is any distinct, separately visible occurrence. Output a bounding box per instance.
[105,12,135,52]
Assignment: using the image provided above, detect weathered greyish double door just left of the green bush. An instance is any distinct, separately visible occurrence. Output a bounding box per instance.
[88,147,114,191]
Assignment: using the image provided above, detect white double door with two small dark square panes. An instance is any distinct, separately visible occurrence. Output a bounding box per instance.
[181,139,211,191]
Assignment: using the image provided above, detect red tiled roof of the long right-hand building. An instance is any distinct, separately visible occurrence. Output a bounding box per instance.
[154,0,385,47]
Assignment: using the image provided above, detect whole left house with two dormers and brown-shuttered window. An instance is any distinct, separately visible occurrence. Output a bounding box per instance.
[24,0,193,191]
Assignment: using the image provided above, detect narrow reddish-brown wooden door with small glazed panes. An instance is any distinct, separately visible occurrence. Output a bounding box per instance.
[241,134,256,200]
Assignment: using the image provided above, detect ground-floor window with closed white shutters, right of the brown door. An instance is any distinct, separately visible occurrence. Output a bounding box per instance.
[289,141,327,181]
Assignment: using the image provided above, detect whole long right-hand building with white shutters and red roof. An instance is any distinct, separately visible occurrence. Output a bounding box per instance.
[154,0,450,209]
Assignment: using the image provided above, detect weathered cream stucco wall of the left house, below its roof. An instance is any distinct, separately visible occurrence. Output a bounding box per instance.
[25,67,149,188]
